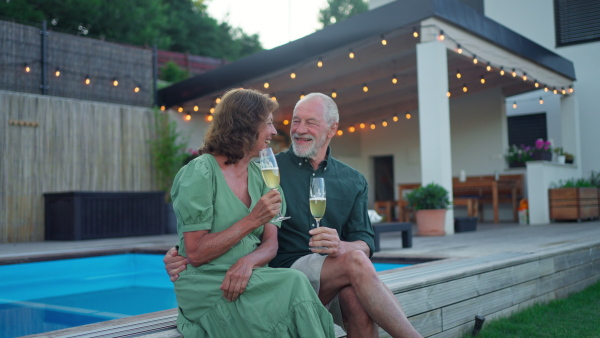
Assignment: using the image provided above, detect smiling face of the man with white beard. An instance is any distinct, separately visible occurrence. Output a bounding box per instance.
[290,100,335,158]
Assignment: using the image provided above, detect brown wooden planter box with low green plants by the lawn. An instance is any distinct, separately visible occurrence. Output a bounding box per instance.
[548,171,600,221]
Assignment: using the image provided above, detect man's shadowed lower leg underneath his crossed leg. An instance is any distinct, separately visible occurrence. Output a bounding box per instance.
[338,286,379,338]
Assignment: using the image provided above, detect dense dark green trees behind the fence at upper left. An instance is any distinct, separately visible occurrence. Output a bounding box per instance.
[0,0,262,61]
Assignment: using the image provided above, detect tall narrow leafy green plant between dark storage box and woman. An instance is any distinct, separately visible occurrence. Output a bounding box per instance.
[149,108,188,233]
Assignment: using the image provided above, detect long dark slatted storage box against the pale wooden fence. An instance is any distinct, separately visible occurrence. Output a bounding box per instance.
[44,191,166,240]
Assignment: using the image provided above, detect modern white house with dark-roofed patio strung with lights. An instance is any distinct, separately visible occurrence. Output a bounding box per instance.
[158,0,600,234]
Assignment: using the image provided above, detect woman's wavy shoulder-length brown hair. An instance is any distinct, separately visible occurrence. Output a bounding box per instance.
[200,88,279,164]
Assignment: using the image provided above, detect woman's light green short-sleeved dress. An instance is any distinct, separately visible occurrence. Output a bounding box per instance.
[171,154,334,338]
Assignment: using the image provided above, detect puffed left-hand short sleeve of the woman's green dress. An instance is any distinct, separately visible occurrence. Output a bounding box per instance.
[171,158,214,232]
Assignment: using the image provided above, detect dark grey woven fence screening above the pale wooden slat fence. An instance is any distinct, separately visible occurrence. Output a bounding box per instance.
[0,21,153,106]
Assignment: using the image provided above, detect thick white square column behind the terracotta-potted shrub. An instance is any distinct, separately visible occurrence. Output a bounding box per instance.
[417,40,454,234]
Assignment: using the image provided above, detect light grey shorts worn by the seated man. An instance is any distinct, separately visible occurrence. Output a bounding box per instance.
[290,253,346,330]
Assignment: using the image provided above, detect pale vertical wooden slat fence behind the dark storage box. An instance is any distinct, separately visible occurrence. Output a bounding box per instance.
[0,91,165,243]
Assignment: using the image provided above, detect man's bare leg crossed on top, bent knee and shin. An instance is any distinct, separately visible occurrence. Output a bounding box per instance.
[319,250,421,337]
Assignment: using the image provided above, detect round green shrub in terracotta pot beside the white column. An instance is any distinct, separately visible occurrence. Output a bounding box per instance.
[406,183,450,236]
